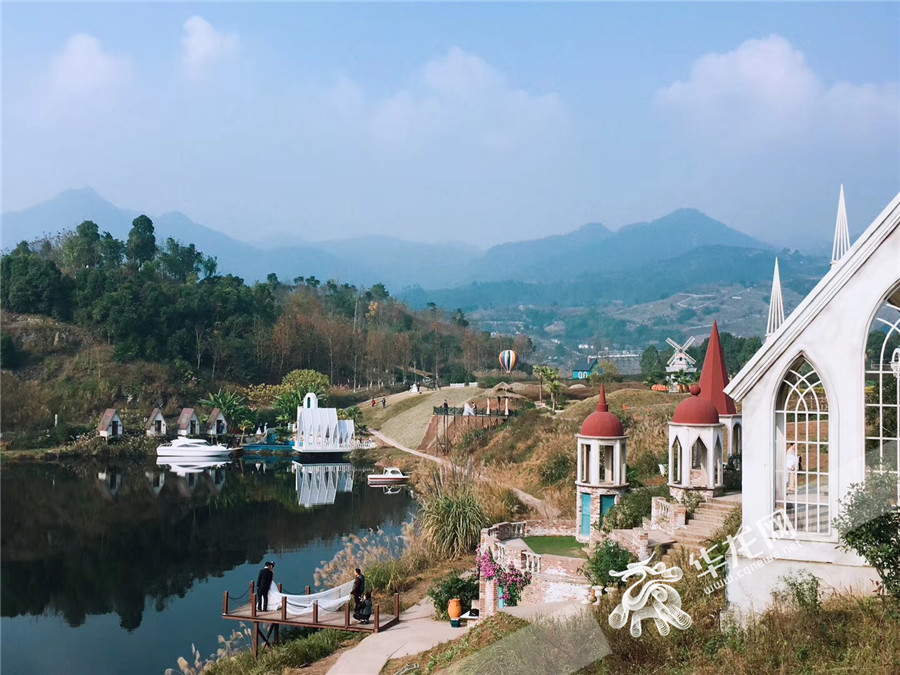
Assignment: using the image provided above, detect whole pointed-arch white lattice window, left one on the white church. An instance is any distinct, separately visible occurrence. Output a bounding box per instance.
[775,357,831,535]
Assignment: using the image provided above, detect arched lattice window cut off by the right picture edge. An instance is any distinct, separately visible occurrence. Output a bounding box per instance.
[865,285,900,498]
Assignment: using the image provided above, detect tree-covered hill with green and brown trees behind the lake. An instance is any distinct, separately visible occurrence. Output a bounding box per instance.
[0,216,529,386]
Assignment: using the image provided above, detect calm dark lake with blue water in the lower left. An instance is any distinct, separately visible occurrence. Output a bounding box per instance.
[0,458,413,675]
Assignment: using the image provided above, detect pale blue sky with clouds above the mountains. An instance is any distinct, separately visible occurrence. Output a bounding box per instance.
[0,2,900,247]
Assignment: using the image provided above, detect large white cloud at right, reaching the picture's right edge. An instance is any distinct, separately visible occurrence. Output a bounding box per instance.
[657,35,900,141]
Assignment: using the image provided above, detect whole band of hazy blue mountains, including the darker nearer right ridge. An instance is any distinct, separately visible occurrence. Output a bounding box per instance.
[0,188,788,296]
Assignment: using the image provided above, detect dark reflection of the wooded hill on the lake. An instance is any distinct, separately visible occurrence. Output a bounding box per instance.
[0,458,411,636]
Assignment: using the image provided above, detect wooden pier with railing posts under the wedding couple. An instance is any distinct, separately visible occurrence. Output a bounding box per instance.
[222,581,400,658]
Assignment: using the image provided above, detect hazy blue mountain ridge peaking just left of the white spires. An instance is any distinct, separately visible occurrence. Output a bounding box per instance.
[467,209,771,282]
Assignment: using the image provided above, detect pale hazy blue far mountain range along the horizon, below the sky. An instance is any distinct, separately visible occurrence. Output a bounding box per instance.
[0,188,788,297]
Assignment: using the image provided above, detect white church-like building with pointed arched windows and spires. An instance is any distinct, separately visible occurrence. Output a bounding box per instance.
[725,188,900,610]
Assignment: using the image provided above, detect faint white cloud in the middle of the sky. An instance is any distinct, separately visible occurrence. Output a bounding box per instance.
[371,47,565,150]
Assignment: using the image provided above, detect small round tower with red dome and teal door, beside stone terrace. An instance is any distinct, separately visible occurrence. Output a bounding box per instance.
[575,385,628,542]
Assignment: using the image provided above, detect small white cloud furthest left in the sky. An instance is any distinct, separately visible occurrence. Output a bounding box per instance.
[44,33,133,106]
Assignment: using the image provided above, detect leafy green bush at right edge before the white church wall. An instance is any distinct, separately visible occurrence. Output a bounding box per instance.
[834,473,900,598]
